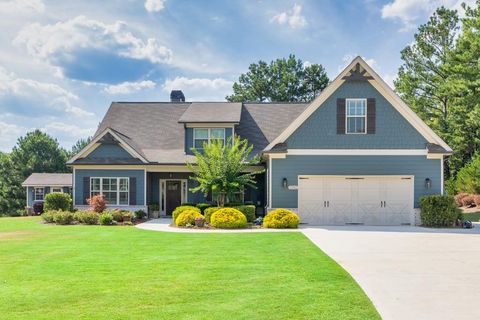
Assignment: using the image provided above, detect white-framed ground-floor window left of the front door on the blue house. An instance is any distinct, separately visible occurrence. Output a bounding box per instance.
[90,178,129,205]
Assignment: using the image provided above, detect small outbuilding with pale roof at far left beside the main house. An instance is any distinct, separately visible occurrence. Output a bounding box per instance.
[22,173,72,207]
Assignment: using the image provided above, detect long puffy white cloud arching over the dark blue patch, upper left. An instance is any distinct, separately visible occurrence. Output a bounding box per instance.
[14,16,172,63]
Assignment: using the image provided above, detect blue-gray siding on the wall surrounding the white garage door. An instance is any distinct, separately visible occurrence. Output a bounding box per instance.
[271,156,442,208]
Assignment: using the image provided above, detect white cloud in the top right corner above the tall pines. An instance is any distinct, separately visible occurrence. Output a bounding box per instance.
[382,0,475,31]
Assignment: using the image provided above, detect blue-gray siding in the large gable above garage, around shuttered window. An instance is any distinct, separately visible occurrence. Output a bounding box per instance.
[286,82,427,149]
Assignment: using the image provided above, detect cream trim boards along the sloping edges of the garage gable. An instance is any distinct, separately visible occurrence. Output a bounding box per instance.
[264,57,452,151]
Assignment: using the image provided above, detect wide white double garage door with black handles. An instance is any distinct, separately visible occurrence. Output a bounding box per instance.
[298,176,414,225]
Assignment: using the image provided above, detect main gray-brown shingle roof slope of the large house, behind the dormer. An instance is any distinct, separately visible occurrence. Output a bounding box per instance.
[89,102,308,164]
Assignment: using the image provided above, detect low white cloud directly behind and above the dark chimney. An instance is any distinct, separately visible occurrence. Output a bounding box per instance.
[163,77,233,101]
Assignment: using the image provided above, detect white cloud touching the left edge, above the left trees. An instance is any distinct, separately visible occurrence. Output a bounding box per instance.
[0,67,93,117]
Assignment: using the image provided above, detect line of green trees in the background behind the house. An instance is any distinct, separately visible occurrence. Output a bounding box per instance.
[0,0,480,213]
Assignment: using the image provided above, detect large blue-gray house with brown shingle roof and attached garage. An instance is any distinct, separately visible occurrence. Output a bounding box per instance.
[68,57,452,225]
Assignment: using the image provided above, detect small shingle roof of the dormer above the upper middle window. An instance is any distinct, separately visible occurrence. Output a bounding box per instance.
[178,102,242,123]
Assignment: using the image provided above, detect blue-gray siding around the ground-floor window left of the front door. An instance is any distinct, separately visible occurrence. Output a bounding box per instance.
[75,169,145,206]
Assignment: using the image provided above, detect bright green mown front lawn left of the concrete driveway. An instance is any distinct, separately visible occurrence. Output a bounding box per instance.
[0,217,380,319]
